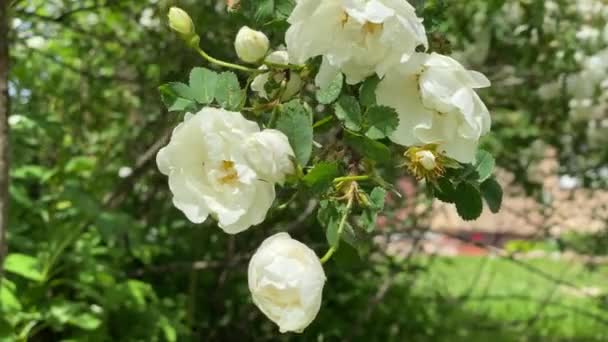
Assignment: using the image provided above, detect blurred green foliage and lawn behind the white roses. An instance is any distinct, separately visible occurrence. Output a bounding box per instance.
[0,0,608,341]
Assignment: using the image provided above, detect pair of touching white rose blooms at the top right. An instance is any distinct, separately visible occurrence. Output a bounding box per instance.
[286,0,490,163]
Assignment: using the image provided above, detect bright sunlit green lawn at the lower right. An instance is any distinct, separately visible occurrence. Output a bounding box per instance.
[404,257,608,341]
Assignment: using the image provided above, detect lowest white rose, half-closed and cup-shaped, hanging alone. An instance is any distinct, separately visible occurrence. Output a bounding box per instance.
[248,233,326,333]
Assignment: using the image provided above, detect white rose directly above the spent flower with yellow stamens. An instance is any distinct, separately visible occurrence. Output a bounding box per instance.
[376,53,491,163]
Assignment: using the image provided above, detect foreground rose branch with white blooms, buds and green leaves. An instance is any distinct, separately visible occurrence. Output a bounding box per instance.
[157,0,502,332]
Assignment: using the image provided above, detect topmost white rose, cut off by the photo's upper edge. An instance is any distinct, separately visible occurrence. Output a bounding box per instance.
[285,0,428,87]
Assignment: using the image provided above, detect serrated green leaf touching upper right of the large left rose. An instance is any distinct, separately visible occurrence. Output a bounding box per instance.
[276,100,313,166]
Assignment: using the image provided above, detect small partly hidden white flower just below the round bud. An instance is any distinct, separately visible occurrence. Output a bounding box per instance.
[251,51,303,101]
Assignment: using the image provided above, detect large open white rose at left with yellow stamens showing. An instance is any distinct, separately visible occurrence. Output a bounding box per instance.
[156,108,294,234]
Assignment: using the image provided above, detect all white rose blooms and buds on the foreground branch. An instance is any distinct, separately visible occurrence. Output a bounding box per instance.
[163,0,490,332]
